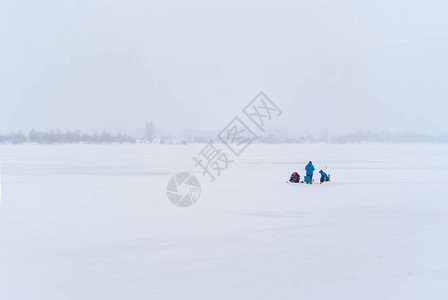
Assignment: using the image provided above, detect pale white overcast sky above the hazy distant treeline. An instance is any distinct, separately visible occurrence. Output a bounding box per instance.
[0,0,448,134]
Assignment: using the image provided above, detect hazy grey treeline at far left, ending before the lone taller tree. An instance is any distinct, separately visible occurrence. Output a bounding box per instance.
[0,129,136,144]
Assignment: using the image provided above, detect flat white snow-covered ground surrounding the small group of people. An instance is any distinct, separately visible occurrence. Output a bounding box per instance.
[0,144,448,300]
